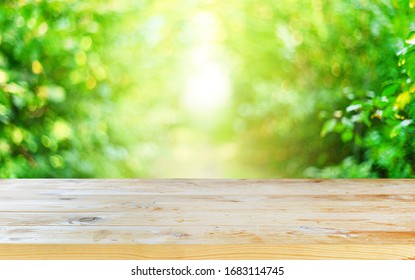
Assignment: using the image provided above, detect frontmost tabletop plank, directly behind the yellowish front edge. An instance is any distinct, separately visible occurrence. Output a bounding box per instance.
[0,225,415,244]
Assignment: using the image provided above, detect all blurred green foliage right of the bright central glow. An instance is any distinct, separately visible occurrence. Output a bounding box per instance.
[223,0,415,177]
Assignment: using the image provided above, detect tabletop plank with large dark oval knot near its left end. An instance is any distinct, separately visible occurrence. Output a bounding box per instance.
[0,212,415,231]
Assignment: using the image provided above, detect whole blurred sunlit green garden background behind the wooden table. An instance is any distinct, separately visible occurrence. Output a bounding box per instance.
[0,0,415,178]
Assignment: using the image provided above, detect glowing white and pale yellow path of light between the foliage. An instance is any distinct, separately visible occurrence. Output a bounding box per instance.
[153,10,235,178]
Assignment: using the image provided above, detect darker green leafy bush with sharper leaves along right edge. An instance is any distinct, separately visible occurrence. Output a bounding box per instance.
[309,1,415,178]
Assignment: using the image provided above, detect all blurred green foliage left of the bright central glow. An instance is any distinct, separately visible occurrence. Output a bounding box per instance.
[0,0,192,177]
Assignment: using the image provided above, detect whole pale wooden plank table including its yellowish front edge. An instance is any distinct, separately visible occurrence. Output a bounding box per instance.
[0,179,415,259]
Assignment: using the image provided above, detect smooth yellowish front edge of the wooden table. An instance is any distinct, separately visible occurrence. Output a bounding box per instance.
[0,244,415,260]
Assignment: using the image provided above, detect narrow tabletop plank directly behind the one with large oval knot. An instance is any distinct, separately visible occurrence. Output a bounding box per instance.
[0,197,415,214]
